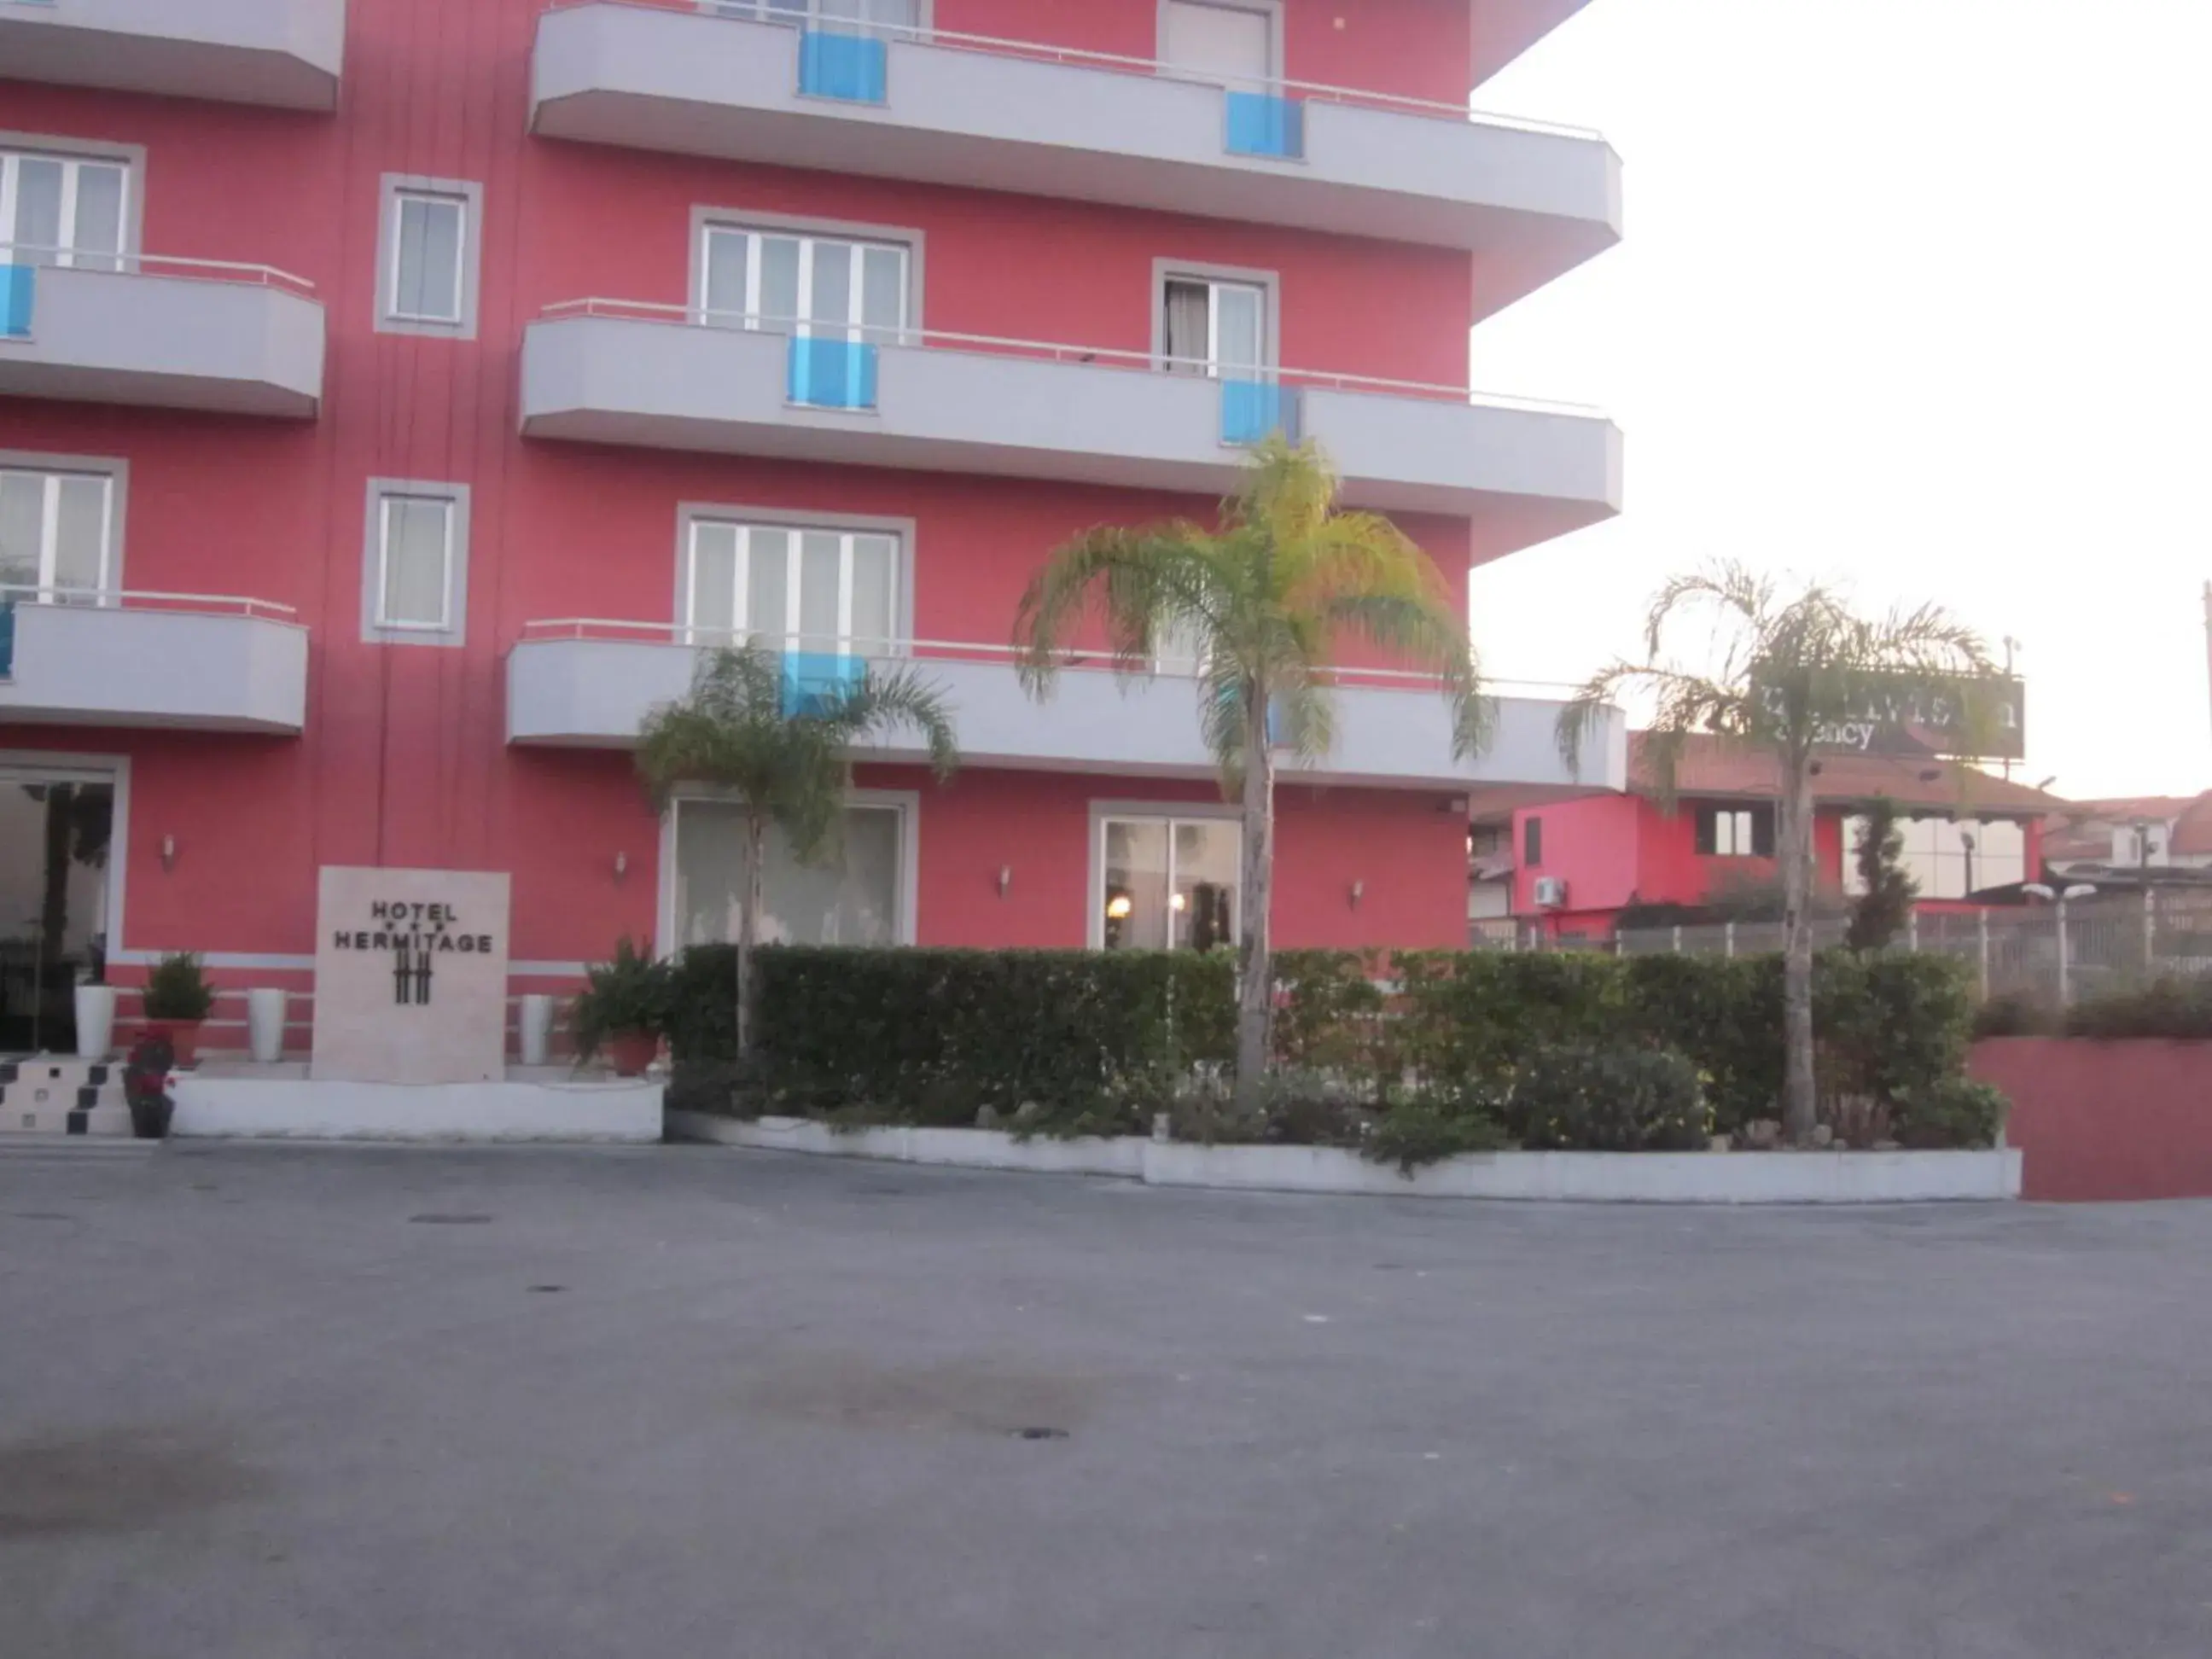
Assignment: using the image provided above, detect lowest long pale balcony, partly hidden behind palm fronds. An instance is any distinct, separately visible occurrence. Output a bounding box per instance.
[507,621,1628,789]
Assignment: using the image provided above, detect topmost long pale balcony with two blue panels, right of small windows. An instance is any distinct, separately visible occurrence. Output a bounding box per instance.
[531,0,1621,314]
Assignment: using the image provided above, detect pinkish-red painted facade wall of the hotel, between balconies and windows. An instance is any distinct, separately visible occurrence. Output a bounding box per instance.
[0,0,1504,963]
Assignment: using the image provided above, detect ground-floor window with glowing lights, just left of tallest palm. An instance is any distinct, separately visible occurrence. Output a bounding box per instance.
[1092,816,1243,952]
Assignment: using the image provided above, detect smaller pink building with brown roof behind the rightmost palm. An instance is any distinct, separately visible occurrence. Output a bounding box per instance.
[1505,732,2064,938]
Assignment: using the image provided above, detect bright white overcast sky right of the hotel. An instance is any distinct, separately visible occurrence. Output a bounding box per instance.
[1473,0,2212,796]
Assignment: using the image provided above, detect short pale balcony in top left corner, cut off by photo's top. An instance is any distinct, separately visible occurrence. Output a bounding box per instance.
[0,0,345,111]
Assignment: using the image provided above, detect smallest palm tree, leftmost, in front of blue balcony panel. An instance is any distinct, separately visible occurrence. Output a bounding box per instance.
[637,642,960,1055]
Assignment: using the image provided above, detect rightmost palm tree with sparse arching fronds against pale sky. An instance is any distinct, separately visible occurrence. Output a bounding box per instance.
[1559,564,2000,1144]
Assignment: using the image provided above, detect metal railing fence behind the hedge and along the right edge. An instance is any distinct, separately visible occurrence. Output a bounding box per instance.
[1469,889,2212,1004]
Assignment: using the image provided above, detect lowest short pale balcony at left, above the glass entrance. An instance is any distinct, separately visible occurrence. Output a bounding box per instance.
[0,588,307,735]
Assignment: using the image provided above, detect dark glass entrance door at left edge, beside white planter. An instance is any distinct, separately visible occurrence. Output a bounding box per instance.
[0,767,115,1055]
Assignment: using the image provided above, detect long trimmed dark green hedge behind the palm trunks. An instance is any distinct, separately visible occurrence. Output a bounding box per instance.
[672,946,1973,1132]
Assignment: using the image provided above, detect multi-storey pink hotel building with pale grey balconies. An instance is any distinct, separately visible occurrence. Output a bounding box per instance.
[0,0,1624,1049]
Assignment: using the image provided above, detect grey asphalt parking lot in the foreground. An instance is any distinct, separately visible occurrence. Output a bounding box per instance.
[0,1146,2212,1659]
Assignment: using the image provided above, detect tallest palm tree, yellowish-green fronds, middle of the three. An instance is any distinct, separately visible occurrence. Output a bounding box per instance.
[1016,434,1488,1099]
